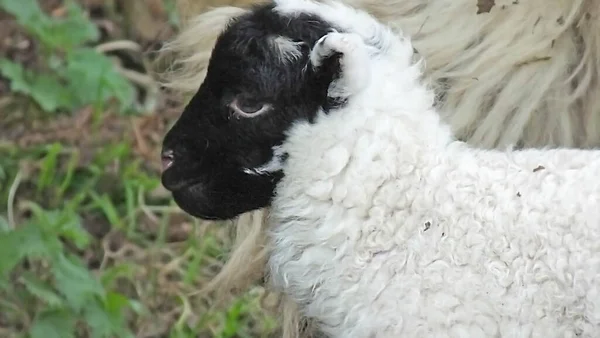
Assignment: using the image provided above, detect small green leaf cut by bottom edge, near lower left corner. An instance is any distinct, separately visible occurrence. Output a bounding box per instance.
[29,310,76,338]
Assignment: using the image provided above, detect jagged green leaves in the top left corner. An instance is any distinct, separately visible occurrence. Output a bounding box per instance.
[0,0,135,112]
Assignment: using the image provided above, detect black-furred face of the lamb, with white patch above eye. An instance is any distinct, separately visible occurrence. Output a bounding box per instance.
[162,4,338,219]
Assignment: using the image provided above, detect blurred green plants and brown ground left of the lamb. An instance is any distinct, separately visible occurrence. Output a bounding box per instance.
[0,0,277,338]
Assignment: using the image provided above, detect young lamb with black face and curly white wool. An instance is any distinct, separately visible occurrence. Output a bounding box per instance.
[163,0,600,337]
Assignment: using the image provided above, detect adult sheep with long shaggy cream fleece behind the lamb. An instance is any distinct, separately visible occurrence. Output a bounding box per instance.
[163,0,600,335]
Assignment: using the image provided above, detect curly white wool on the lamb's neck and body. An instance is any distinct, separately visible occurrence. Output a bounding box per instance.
[269,0,600,338]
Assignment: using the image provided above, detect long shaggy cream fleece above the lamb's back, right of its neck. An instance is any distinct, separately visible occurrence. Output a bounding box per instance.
[356,0,600,147]
